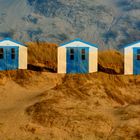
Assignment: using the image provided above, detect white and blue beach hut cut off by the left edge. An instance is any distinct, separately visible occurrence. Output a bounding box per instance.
[0,38,27,70]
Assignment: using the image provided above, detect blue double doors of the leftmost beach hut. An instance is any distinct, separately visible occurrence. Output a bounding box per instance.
[0,46,18,70]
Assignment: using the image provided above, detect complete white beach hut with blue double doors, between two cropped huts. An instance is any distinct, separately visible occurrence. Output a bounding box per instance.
[57,39,98,73]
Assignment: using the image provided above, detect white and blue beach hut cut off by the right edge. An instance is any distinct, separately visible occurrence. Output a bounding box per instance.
[124,41,140,75]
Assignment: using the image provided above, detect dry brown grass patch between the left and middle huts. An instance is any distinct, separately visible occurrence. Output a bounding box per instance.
[27,42,58,70]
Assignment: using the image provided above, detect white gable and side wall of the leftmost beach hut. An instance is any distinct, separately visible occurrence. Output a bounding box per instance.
[0,40,27,69]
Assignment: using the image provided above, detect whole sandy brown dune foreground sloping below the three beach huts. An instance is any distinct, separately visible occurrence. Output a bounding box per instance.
[0,72,140,140]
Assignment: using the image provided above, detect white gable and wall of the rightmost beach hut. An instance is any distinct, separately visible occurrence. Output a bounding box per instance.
[124,43,140,75]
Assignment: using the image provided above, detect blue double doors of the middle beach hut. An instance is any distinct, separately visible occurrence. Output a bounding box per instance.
[67,47,89,73]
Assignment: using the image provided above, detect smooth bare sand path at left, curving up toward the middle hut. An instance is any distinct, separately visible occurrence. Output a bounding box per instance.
[0,73,63,140]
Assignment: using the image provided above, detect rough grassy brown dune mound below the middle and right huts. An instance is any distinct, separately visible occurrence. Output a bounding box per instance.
[26,72,140,140]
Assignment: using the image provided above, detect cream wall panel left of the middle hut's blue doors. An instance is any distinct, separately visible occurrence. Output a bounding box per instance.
[57,47,67,73]
